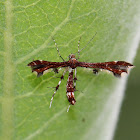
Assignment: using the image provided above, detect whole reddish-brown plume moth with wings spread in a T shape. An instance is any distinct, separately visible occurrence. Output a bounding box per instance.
[28,54,133,106]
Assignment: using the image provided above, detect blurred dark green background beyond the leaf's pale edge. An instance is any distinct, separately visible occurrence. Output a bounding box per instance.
[114,46,140,140]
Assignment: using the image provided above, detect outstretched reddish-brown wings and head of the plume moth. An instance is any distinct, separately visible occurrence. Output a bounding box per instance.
[28,54,133,77]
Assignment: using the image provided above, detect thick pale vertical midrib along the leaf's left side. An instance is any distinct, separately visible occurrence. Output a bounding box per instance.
[1,0,14,140]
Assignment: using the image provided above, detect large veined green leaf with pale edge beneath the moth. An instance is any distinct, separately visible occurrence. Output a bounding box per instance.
[0,0,140,140]
